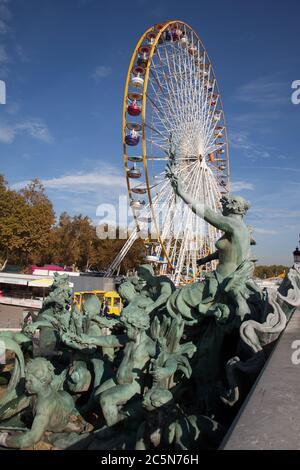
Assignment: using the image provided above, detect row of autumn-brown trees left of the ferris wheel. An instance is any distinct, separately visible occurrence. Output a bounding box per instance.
[0,175,145,274]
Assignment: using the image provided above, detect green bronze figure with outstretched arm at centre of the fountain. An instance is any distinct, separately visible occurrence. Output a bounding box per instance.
[62,288,196,426]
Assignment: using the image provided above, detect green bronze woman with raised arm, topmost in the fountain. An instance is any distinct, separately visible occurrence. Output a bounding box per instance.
[166,165,253,324]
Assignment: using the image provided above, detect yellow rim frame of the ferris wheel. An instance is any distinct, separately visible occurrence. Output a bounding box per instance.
[122,20,230,270]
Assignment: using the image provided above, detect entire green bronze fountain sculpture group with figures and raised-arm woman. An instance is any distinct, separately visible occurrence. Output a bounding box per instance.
[0,166,300,450]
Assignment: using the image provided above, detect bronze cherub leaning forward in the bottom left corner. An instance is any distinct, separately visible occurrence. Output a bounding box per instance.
[0,357,86,449]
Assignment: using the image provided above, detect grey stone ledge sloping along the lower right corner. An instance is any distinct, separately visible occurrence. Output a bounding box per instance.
[222,309,300,450]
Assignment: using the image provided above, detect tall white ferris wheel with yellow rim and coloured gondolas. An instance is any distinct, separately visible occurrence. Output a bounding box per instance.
[108,21,229,285]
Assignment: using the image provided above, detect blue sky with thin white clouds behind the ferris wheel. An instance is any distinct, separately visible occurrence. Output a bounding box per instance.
[0,0,300,264]
